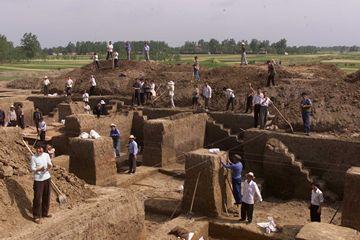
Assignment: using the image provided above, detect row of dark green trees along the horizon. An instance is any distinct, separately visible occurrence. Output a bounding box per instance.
[0,33,360,62]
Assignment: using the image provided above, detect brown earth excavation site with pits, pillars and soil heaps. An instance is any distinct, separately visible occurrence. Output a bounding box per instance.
[0,61,360,240]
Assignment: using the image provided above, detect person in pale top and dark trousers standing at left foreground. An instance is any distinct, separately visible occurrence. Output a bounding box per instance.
[30,143,52,224]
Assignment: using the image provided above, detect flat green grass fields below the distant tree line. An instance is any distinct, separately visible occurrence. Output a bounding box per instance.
[0,52,360,81]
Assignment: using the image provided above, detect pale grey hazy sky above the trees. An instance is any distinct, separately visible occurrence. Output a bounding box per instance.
[0,0,360,47]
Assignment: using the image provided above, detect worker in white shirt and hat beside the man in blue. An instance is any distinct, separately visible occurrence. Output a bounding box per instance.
[240,172,262,223]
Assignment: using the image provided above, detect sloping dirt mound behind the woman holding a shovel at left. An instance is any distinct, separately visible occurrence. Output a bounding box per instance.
[0,128,95,238]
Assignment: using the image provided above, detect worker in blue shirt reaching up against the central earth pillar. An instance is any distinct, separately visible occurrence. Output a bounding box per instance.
[221,156,243,205]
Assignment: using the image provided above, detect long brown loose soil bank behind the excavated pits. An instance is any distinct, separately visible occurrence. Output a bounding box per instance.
[10,61,360,136]
